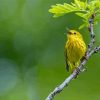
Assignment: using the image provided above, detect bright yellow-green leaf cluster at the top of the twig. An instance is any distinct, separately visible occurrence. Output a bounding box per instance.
[49,0,100,29]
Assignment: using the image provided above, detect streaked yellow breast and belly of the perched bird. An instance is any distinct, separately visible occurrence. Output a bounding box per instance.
[66,37,86,63]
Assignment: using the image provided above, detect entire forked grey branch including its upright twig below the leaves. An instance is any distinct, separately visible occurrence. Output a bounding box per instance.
[46,14,100,100]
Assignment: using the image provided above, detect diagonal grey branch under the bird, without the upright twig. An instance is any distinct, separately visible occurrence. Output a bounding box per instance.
[46,46,100,100]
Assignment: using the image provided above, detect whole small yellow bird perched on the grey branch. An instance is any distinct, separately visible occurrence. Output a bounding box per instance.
[65,30,86,72]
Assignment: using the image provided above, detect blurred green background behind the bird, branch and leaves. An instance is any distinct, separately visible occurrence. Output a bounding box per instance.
[0,0,100,100]
